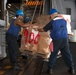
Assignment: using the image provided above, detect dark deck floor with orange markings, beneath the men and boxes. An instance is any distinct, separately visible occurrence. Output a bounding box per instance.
[0,43,76,75]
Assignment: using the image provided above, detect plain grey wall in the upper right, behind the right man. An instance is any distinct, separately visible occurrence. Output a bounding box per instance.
[52,0,76,29]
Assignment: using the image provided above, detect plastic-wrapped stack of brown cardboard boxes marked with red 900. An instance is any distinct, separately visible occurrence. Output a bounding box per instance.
[20,15,52,58]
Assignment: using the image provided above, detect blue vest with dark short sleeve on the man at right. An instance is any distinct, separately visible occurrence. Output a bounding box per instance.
[43,17,68,39]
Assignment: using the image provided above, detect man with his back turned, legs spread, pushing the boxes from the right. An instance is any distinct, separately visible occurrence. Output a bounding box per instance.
[33,9,75,75]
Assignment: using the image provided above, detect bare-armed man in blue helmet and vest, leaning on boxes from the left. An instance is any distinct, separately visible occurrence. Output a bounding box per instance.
[6,10,29,70]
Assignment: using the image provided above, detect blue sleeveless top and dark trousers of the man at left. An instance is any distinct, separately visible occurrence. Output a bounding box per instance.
[6,19,21,64]
